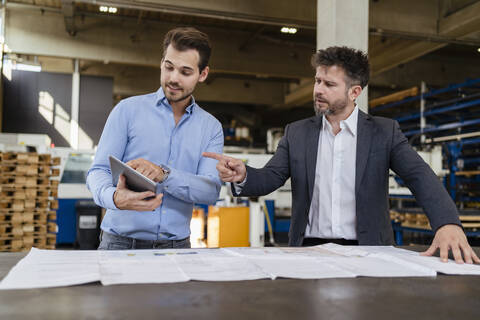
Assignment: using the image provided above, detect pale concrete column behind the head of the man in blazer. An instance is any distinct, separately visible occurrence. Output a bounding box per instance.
[317,0,368,112]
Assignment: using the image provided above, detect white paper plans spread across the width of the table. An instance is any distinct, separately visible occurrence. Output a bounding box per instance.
[0,244,480,289]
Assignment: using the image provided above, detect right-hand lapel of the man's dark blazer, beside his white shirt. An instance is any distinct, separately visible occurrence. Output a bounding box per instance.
[355,110,374,194]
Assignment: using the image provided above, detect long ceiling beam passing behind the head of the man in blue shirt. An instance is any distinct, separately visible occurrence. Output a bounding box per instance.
[6,7,313,79]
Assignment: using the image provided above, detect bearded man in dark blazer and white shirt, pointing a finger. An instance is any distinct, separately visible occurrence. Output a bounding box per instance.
[204,47,480,263]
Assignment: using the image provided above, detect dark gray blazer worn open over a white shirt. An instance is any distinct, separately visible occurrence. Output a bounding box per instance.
[232,111,461,246]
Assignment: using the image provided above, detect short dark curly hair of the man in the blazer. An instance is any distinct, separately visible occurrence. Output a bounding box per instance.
[312,47,370,89]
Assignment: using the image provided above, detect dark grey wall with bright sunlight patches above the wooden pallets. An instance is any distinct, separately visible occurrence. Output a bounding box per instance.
[3,70,113,148]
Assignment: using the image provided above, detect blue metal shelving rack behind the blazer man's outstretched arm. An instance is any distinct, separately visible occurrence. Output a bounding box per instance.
[370,78,480,244]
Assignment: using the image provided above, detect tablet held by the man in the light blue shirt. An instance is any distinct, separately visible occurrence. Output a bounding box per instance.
[109,156,157,194]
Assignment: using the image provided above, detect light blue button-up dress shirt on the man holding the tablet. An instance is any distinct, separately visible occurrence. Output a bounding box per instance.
[87,88,223,240]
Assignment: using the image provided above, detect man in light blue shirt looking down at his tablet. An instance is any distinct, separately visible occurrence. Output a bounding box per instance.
[87,28,223,250]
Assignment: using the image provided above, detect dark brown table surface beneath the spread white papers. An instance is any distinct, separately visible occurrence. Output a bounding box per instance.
[0,247,480,320]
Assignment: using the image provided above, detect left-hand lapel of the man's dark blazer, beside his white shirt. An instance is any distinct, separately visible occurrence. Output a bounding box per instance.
[305,116,322,202]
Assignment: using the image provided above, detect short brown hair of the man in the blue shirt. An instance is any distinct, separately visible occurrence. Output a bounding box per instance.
[163,27,212,72]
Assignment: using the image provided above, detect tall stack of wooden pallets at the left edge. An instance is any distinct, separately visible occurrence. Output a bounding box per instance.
[0,152,60,251]
